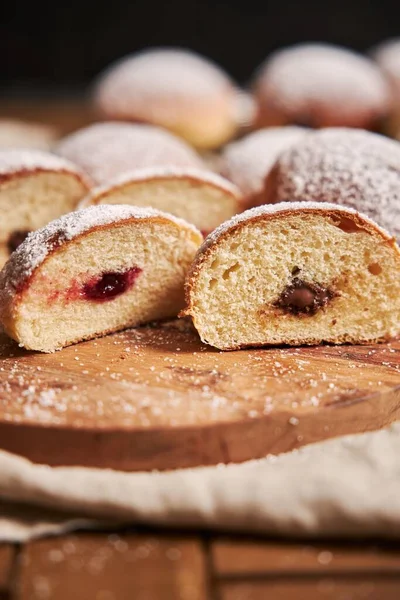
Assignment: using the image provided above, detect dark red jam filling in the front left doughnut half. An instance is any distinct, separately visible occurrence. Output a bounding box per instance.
[81,267,142,302]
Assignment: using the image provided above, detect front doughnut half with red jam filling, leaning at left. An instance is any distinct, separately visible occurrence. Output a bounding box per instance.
[0,205,203,352]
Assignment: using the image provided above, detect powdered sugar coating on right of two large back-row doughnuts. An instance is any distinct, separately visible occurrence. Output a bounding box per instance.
[256,44,390,114]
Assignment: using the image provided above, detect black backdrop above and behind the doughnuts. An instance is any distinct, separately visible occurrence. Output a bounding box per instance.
[0,0,400,94]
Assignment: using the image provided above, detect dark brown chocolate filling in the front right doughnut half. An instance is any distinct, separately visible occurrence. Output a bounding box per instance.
[275,277,336,315]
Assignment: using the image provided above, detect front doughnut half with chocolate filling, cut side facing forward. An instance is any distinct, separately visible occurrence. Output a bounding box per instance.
[184,202,400,350]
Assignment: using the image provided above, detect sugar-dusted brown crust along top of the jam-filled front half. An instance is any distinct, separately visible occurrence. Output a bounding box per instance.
[0,204,201,304]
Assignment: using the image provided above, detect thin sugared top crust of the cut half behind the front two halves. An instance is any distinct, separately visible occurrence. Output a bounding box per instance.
[82,166,241,206]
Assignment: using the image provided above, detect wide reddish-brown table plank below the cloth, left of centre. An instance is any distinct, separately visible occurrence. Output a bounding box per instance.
[17,534,208,600]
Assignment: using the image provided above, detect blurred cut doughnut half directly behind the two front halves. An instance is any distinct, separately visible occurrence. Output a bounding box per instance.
[81,167,242,235]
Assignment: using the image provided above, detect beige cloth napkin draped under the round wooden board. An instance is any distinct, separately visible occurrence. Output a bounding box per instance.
[0,422,400,541]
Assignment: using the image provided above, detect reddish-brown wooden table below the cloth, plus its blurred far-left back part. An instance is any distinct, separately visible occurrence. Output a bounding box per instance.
[0,100,400,600]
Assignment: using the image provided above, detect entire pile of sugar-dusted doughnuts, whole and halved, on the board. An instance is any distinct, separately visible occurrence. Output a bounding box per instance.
[0,41,400,352]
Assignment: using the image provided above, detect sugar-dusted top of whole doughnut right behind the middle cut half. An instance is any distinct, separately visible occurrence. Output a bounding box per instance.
[55,121,206,184]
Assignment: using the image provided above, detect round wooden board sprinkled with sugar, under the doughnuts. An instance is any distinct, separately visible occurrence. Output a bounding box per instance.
[0,321,400,471]
